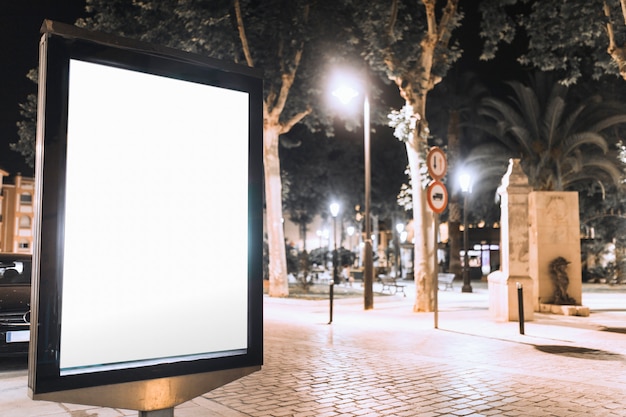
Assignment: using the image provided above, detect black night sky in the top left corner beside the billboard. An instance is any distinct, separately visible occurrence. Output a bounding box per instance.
[0,0,85,176]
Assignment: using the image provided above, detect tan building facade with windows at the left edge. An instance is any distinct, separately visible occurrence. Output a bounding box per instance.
[0,170,35,254]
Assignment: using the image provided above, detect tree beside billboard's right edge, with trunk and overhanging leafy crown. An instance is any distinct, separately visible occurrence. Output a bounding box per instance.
[14,0,349,297]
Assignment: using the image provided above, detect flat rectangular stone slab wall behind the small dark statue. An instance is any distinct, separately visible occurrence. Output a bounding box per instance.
[528,191,583,308]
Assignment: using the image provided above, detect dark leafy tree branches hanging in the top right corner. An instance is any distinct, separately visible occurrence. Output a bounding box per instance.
[479,0,626,85]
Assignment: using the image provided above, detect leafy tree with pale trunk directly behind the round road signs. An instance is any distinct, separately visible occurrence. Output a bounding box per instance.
[348,0,463,311]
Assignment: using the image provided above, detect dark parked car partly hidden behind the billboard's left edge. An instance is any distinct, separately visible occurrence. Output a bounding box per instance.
[0,253,32,356]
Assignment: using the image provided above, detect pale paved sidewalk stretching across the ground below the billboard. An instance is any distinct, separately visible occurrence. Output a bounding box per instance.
[0,283,626,417]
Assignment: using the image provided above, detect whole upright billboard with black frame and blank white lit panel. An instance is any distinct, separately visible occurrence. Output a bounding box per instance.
[29,21,263,406]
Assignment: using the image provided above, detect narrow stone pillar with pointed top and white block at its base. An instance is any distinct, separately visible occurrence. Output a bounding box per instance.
[488,159,534,321]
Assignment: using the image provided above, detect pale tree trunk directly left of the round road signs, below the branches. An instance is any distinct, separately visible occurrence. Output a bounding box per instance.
[406,139,436,312]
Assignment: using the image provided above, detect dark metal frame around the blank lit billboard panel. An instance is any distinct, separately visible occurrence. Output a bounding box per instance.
[29,21,263,410]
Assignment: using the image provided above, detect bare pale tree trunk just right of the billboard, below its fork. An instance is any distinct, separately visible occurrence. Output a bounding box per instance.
[263,126,289,297]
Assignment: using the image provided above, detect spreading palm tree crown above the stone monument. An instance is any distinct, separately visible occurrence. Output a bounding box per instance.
[470,73,626,191]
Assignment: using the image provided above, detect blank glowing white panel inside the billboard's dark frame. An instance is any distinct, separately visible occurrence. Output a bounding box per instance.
[59,59,249,375]
